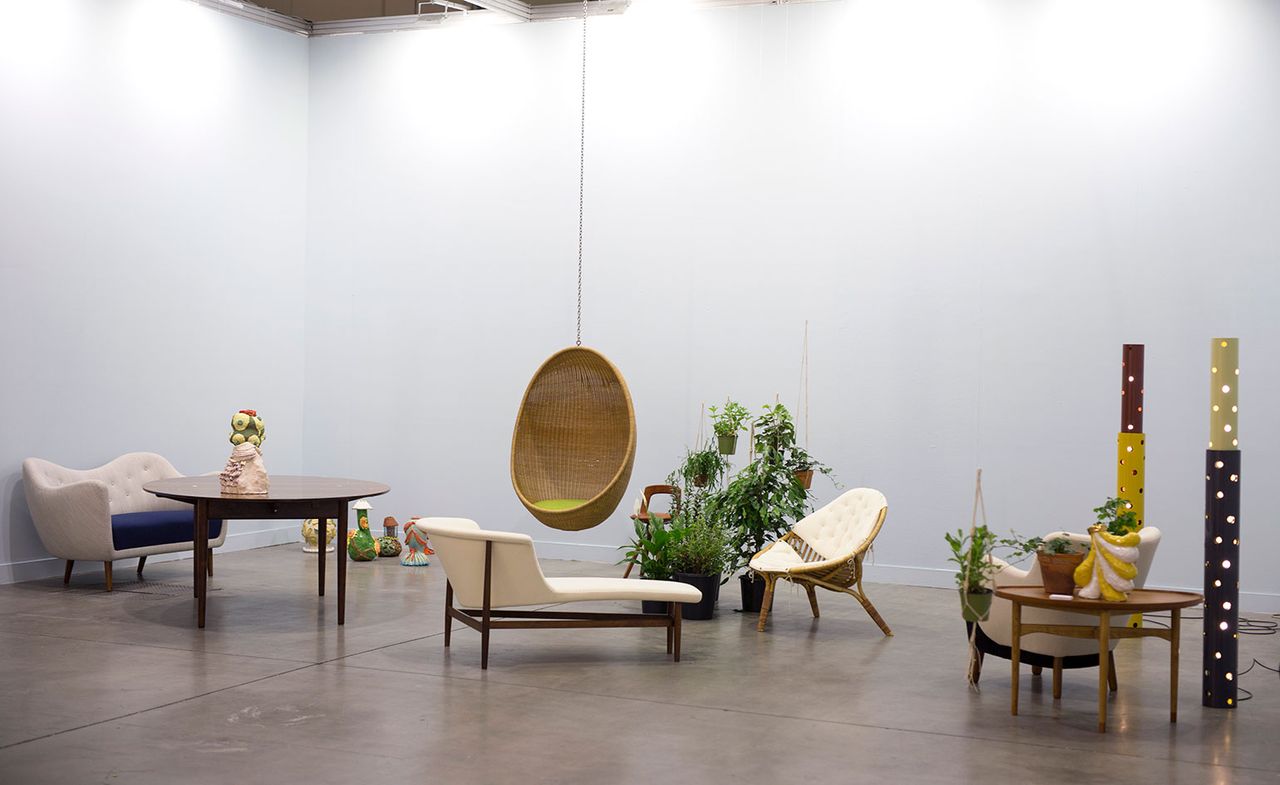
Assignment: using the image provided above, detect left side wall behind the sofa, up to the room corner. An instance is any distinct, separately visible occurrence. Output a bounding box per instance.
[0,0,307,583]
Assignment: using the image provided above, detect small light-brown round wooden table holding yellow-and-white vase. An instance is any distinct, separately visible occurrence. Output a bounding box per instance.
[996,587,1204,732]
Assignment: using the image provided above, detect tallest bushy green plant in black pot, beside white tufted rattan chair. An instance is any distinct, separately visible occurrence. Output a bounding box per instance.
[707,403,809,611]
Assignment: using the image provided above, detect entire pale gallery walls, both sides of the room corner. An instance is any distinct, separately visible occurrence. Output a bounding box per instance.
[0,0,1280,611]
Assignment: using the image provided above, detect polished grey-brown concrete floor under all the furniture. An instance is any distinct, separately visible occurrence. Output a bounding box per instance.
[0,546,1280,785]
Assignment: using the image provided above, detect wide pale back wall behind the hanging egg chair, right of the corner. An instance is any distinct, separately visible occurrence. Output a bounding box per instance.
[307,0,1280,610]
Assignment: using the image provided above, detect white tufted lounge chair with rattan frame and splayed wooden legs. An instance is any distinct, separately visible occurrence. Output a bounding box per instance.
[750,488,893,635]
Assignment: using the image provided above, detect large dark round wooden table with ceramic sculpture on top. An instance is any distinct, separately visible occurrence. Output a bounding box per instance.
[142,474,390,627]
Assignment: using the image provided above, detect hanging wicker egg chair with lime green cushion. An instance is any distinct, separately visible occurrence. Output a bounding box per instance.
[511,346,636,531]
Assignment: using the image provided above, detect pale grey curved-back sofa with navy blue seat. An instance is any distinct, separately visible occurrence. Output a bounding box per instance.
[22,452,227,592]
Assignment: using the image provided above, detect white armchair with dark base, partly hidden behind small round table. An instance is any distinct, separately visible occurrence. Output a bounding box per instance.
[973,526,1160,698]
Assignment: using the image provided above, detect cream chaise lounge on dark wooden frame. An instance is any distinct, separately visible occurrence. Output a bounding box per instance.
[419,517,703,668]
